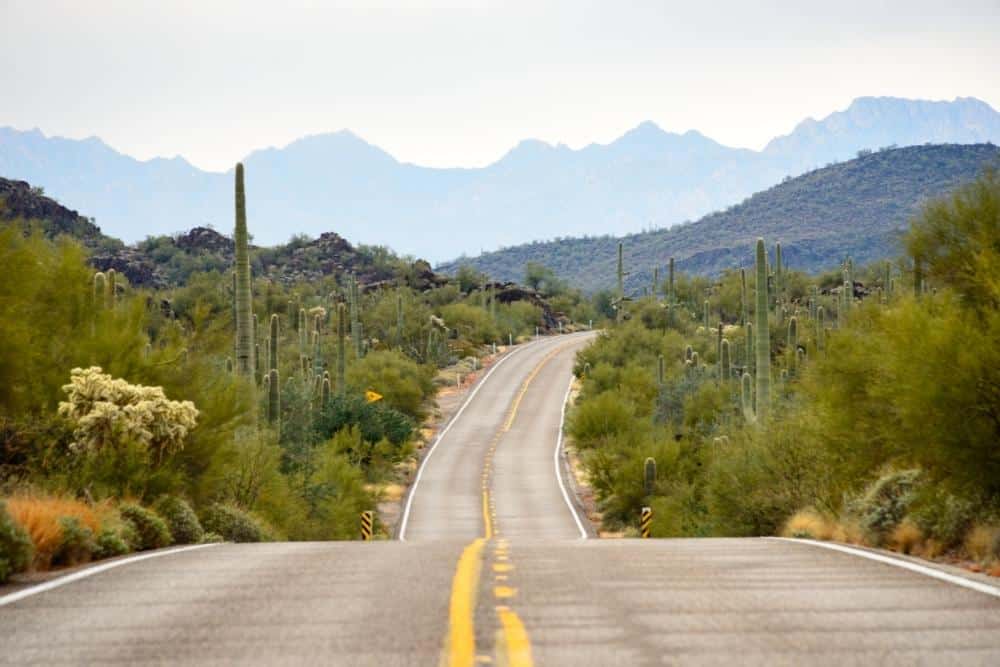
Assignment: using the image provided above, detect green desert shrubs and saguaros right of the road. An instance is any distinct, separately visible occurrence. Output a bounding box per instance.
[568,171,1000,568]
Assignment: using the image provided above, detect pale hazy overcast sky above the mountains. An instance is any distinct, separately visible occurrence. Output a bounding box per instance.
[0,0,1000,170]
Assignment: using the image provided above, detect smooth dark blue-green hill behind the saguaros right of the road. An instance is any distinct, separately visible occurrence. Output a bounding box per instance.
[438,144,1000,291]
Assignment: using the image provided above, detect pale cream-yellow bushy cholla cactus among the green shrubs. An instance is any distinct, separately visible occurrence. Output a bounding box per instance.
[59,366,198,461]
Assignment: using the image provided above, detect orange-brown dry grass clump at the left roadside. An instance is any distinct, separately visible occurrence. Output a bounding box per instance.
[5,494,100,569]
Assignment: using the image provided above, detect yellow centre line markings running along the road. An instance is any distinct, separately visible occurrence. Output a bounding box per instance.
[441,345,569,667]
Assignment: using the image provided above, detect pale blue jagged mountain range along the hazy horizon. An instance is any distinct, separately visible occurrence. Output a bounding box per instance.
[0,97,1000,261]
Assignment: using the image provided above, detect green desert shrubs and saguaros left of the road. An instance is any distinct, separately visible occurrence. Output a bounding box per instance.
[0,167,588,580]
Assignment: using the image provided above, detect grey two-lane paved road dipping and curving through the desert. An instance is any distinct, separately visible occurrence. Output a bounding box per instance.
[0,336,1000,665]
